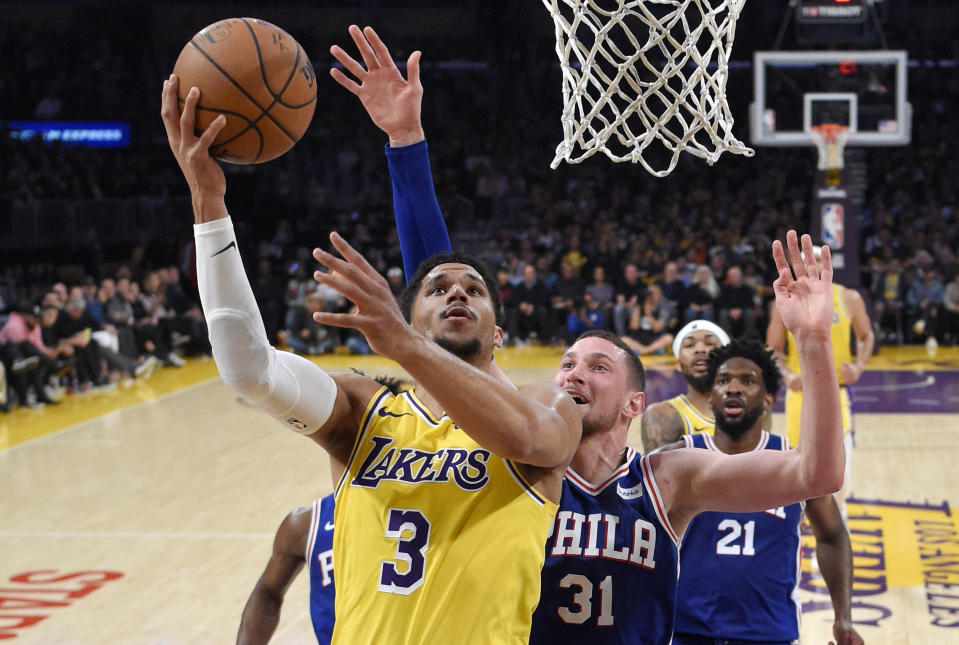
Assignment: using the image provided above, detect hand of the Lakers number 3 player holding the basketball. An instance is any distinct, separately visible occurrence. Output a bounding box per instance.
[160,74,226,200]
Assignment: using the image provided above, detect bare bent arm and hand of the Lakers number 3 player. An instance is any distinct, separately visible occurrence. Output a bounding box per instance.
[313,233,581,468]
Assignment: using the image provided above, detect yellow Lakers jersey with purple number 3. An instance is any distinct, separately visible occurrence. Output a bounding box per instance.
[333,388,556,645]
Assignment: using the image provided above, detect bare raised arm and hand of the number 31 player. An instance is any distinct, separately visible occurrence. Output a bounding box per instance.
[651,231,844,530]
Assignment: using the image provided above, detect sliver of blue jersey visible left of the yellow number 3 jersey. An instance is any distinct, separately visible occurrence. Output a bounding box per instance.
[306,495,335,645]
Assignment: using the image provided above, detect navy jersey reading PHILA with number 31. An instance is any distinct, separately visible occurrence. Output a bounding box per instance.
[530,449,679,645]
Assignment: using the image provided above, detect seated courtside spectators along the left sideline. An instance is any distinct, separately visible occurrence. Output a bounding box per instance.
[0,266,210,411]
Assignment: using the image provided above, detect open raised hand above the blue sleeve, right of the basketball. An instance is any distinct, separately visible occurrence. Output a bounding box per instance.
[330,25,425,147]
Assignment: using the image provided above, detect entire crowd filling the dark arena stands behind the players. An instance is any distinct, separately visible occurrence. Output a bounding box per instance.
[0,8,959,412]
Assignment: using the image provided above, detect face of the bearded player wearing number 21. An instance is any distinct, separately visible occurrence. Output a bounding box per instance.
[709,356,772,439]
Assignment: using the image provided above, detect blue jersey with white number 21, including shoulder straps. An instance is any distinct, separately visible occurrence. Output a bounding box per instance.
[676,432,805,643]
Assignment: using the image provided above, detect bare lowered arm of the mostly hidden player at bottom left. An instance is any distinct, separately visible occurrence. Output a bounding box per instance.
[236,508,311,645]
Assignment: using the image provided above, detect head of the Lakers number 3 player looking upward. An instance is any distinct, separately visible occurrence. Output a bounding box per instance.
[411,262,503,359]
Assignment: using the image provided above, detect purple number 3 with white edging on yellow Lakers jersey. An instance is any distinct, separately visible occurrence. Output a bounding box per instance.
[377,508,431,596]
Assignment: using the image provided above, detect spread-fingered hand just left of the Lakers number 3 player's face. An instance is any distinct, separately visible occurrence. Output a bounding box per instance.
[313,232,408,358]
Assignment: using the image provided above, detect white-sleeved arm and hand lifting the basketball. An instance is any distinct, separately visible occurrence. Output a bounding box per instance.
[160,75,376,462]
